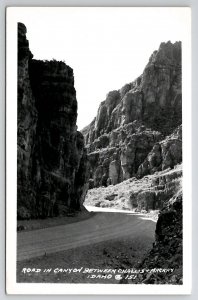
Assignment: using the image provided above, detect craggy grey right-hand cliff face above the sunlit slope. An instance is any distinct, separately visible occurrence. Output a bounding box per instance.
[82,42,182,188]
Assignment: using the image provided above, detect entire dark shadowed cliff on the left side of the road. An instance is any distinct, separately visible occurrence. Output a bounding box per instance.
[17,23,88,218]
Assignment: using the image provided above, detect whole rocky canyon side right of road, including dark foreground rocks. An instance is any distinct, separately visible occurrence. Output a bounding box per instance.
[82,42,183,284]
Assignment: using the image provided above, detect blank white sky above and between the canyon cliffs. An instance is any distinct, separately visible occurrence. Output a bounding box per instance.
[17,8,188,130]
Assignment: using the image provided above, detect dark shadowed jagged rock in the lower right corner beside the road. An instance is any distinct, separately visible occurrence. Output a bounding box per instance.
[133,190,183,285]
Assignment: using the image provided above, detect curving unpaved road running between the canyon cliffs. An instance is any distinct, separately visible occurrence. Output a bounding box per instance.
[17,209,155,261]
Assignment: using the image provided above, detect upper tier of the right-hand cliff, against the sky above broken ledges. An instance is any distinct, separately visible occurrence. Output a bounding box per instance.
[82,42,182,144]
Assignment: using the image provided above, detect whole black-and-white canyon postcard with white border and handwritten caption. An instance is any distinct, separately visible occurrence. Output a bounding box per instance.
[6,7,191,294]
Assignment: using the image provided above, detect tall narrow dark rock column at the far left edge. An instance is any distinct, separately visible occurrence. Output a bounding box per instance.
[17,23,38,218]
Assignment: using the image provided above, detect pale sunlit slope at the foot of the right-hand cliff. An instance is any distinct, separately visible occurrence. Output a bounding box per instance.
[84,164,182,213]
